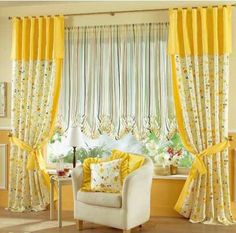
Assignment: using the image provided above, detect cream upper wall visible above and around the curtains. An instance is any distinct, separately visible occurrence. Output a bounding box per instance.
[0,1,236,132]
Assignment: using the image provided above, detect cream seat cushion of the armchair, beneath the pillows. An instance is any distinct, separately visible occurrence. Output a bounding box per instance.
[77,191,122,208]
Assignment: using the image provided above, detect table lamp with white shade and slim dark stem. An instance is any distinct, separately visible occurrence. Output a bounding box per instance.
[68,126,82,168]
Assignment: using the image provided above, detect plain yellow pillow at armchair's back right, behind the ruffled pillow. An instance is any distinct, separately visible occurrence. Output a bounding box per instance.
[112,150,145,174]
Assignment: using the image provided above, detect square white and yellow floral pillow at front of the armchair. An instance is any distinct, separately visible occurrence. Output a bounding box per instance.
[90,159,122,193]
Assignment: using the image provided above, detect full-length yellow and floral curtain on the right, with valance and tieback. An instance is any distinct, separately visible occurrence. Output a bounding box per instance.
[168,6,233,224]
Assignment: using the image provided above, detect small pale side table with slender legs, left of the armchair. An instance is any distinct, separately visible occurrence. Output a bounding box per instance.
[50,175,72,227]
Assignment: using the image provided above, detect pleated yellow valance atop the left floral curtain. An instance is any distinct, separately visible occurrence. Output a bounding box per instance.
[11,16,64,61]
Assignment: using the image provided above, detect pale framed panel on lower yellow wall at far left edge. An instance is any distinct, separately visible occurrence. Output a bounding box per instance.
[0,144,7,190]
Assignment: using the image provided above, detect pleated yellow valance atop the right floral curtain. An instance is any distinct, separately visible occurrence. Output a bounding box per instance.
[168,6,232,56]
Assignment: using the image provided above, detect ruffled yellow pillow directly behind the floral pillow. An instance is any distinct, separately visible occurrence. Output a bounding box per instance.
[80,154,129,192]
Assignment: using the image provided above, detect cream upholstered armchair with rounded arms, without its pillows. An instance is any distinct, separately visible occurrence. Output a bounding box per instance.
[72,158,153,233]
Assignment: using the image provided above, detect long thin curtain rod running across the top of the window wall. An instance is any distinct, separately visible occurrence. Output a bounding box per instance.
[8,4,236,20]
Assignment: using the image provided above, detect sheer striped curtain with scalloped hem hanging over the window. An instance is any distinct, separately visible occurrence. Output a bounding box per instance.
[60,23,174,139]
